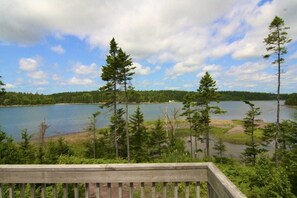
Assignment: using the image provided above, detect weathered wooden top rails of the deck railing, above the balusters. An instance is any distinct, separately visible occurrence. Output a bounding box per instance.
[0,163,245,198]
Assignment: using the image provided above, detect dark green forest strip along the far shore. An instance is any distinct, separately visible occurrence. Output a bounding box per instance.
[0,90,297,106]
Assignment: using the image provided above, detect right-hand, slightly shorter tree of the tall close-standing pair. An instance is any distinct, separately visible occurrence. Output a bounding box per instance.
[118,48,136,162]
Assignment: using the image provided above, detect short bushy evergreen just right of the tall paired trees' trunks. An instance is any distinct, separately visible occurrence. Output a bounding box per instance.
[130,107,148,162]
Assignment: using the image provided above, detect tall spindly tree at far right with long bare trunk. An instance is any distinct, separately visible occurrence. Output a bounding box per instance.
[263,16,292,165]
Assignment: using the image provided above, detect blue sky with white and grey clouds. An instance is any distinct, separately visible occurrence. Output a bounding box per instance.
[0,0,297,94]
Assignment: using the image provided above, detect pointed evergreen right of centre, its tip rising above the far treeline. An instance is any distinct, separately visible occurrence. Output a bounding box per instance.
[195,72,223,156]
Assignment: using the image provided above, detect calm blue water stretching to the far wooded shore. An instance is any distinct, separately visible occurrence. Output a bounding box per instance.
[0,101,297,140]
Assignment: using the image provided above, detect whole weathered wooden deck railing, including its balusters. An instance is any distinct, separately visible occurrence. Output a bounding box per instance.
[0,163,245,198]
